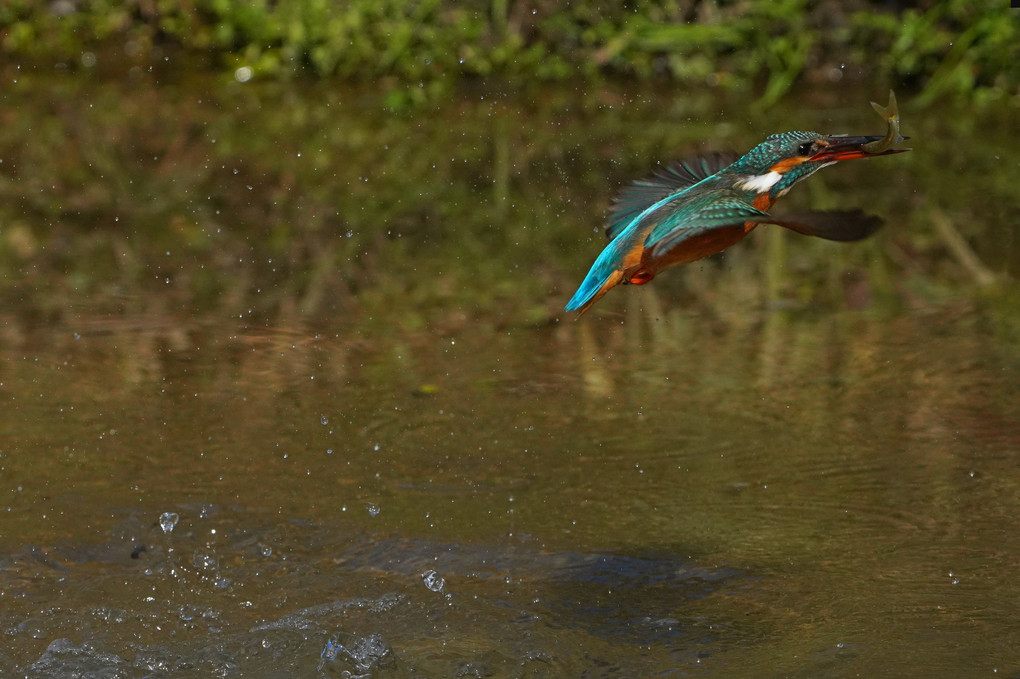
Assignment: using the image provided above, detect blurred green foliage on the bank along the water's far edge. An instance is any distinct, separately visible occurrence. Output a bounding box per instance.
[0,0,1020,104]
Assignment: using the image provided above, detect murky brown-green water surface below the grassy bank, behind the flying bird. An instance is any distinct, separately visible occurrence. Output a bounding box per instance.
[0,67,1020,677]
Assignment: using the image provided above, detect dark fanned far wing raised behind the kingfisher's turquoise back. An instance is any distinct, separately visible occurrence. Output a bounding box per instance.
[606,153,737,241]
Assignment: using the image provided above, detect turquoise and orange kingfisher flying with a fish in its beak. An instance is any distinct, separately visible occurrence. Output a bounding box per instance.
[566,129,910,316]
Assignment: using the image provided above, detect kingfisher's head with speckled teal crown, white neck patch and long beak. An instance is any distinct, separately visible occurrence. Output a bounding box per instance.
[727,132,909,199]
